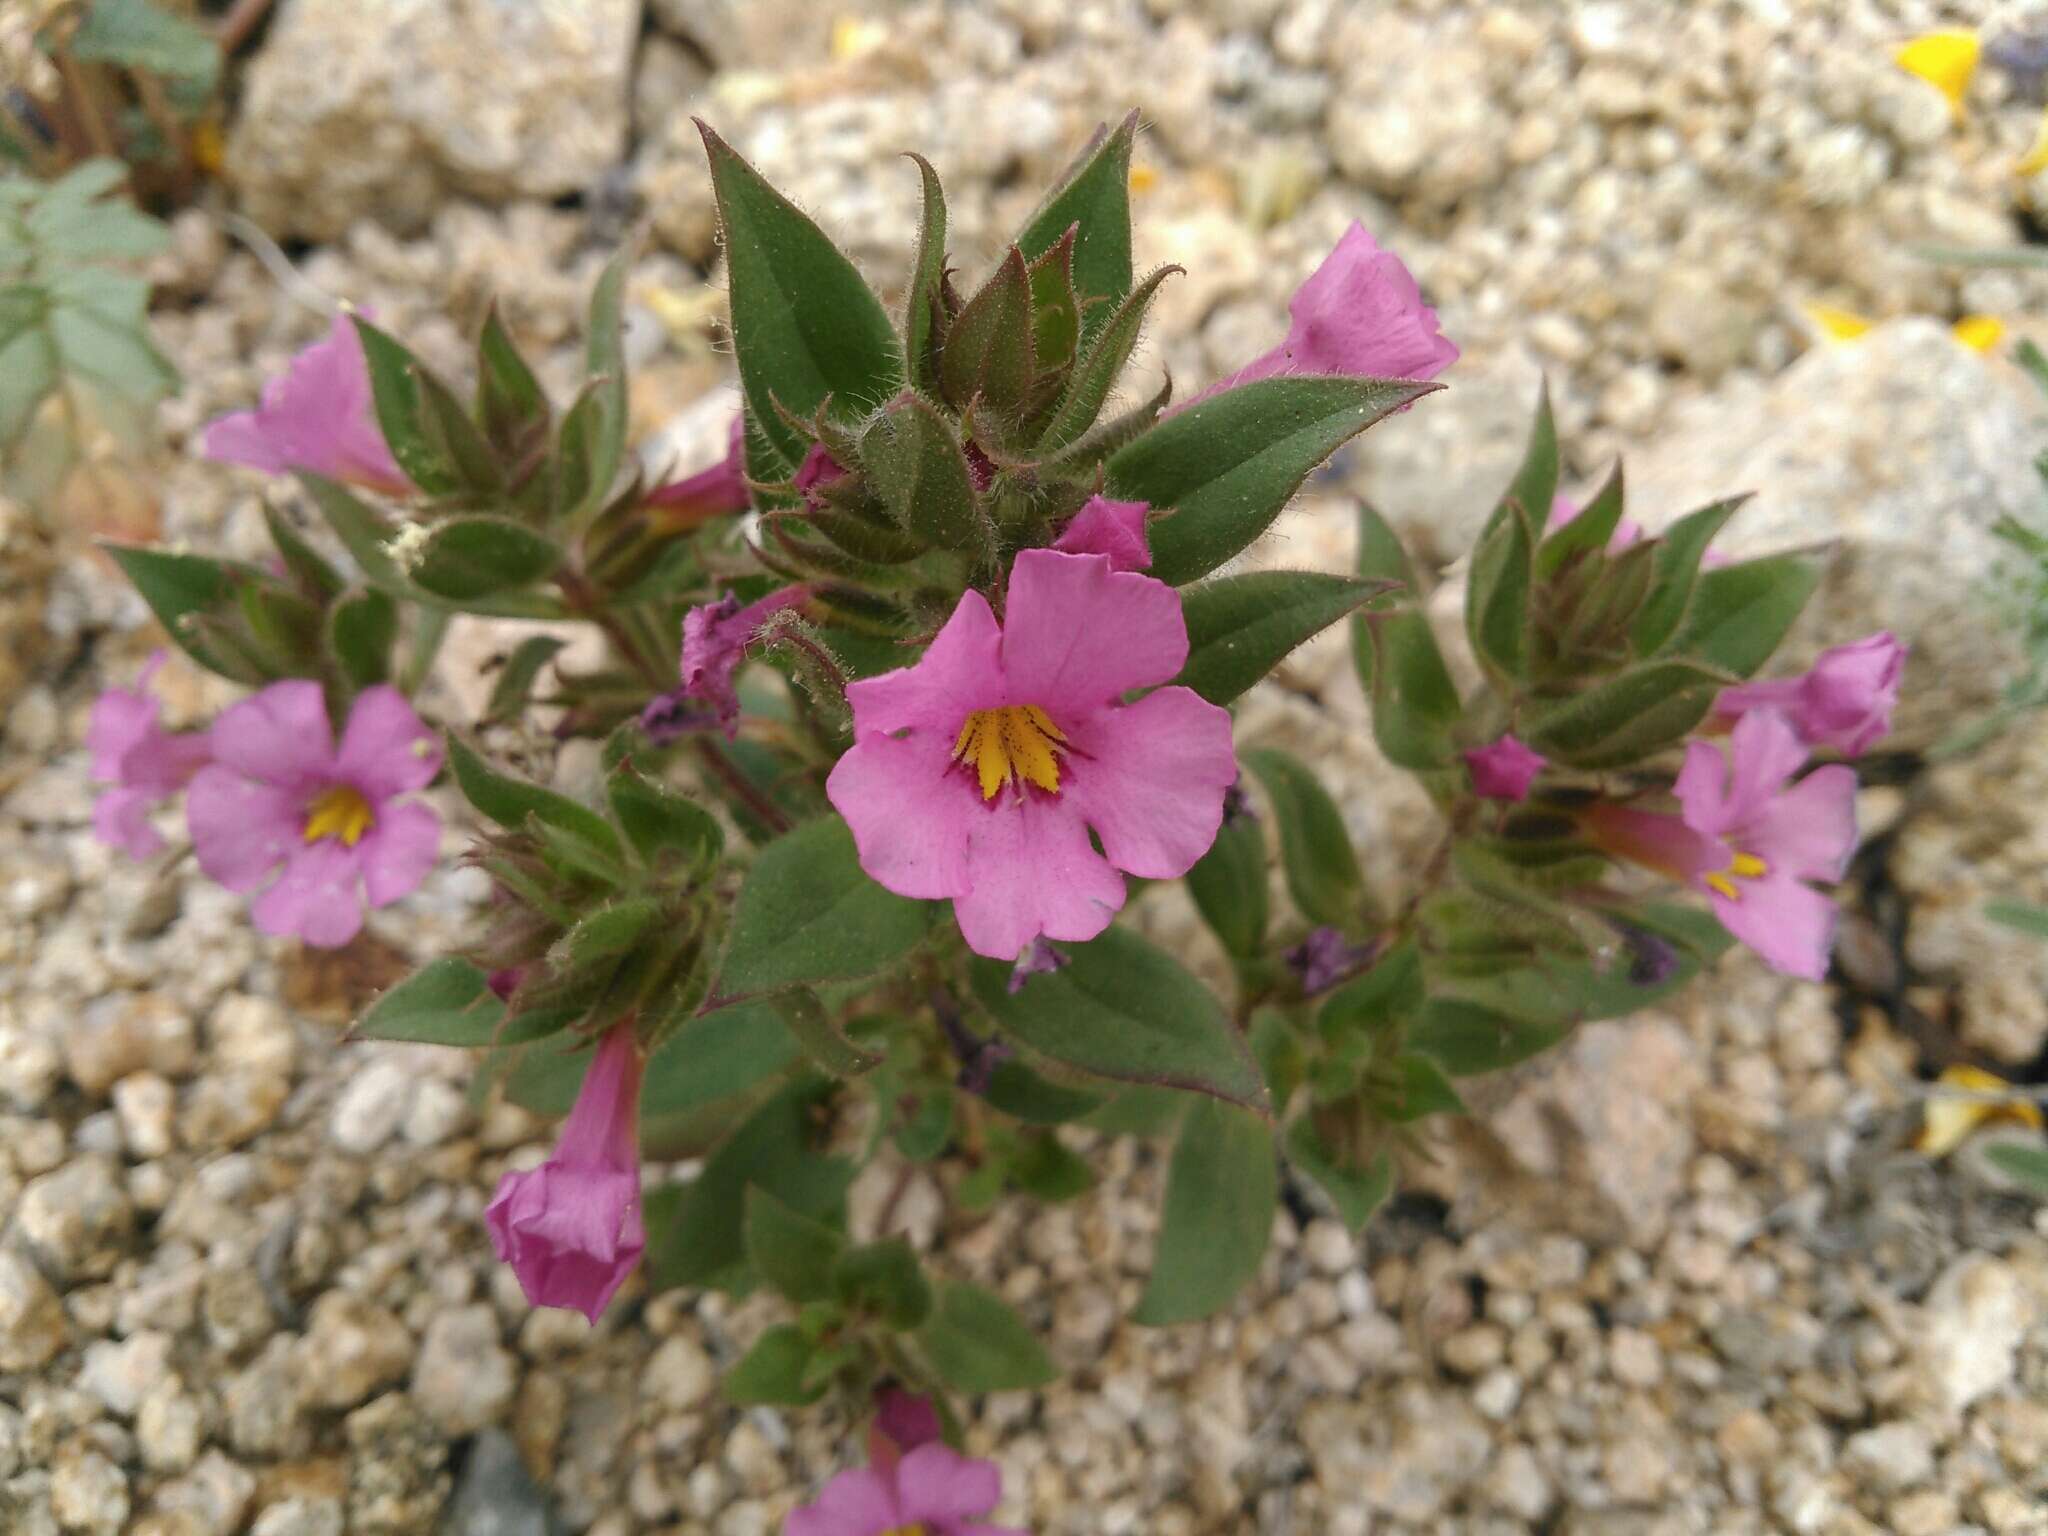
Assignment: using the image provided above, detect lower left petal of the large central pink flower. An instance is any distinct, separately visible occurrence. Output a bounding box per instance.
[825,733,983,901]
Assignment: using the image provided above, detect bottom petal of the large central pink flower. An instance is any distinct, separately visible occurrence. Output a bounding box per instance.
[952,791,1124,961]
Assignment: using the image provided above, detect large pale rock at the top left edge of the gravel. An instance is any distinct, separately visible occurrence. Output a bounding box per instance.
[227,0,639,240]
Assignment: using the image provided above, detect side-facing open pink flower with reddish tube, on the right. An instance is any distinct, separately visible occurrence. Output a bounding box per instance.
[1583,709,1855,981]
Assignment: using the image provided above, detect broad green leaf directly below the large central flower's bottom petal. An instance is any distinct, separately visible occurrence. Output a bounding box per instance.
[975,928,1266,1104]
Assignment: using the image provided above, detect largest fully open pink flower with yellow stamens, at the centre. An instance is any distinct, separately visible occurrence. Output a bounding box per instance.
[825,549,1237,961]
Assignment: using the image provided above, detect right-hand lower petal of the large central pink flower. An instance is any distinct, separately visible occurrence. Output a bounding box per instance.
[1061,688,1237,881]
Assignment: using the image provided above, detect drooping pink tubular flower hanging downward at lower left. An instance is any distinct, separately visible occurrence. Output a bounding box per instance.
[483,1018,647,1323]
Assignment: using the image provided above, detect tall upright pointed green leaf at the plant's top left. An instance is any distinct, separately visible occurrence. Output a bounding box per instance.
[696,121,903,473]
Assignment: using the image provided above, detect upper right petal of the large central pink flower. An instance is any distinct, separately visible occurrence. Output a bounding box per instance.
[1004,549,1188,708]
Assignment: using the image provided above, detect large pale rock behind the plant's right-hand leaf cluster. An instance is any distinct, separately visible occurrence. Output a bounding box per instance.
[1628,319,2048,745]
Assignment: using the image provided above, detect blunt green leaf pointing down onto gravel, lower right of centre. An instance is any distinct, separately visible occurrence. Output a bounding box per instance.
[1130,1100,1280,1327]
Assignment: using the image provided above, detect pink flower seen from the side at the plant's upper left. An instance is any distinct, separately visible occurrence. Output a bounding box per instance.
[207,315,412,496]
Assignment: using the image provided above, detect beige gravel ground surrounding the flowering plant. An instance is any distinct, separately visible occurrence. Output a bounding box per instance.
[0,0,2048,1536]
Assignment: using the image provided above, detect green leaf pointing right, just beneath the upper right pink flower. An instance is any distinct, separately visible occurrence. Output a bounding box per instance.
[1108,377,1436,586]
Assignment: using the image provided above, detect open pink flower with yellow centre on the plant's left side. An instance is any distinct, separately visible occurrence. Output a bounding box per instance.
[186,678,440,948]
